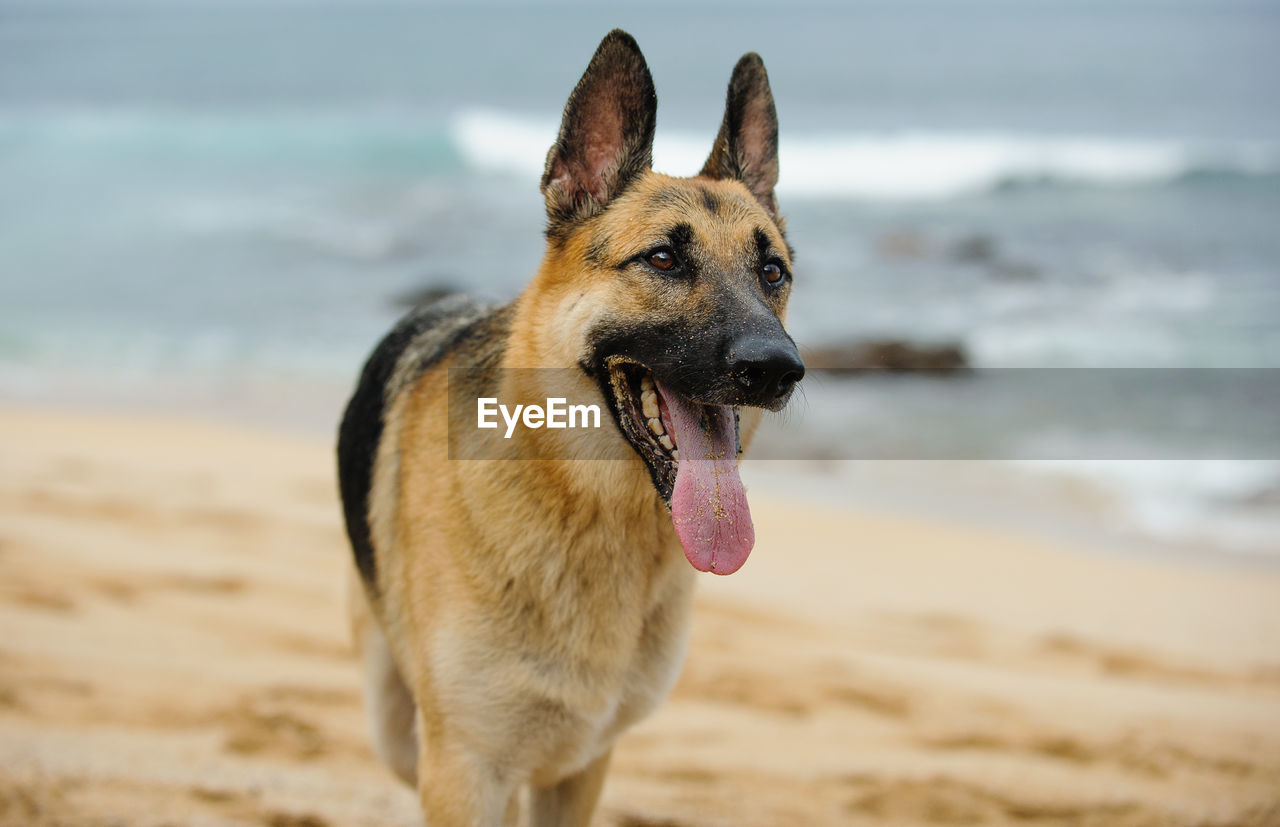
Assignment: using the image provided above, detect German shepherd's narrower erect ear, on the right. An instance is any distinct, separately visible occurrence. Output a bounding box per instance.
[701,51,778,218]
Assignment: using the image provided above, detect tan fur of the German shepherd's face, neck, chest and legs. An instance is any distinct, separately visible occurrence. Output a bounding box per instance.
[351,40,790,827]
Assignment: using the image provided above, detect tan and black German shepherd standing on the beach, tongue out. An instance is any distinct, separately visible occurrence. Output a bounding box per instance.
[338,31,804,827]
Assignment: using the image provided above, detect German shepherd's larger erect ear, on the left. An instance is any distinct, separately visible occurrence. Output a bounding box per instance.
[541,28,658,237]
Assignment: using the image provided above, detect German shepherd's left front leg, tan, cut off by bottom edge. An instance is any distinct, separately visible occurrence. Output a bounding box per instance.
[417,718,522,827]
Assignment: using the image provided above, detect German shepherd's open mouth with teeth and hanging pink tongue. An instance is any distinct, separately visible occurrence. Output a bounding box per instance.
[608,360,755,575]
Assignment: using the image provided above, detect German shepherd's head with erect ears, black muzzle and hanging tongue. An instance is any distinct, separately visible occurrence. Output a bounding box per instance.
[541,31,804,574]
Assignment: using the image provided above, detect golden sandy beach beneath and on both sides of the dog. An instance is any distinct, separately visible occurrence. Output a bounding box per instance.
[0,410,1280,827]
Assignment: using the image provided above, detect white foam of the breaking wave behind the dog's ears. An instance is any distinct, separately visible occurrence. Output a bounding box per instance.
[449,110,1280,200]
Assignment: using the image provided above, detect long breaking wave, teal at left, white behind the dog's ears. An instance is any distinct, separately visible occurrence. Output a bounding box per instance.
[0,109,1280,201]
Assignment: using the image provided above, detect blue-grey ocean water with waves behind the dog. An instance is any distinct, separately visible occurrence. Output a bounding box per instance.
[0,0,1280,553]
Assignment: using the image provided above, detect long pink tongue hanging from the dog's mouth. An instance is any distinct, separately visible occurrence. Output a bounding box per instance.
[658,383,755,575]
